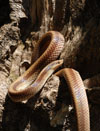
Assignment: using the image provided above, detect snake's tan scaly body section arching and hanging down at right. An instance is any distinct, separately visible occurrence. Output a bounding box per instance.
[55,68,90,131]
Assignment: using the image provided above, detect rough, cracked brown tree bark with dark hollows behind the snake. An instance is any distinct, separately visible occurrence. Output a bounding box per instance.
[0,0,100,131]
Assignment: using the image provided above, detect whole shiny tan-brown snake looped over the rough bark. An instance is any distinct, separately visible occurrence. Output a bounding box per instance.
[8,31,90,131]
